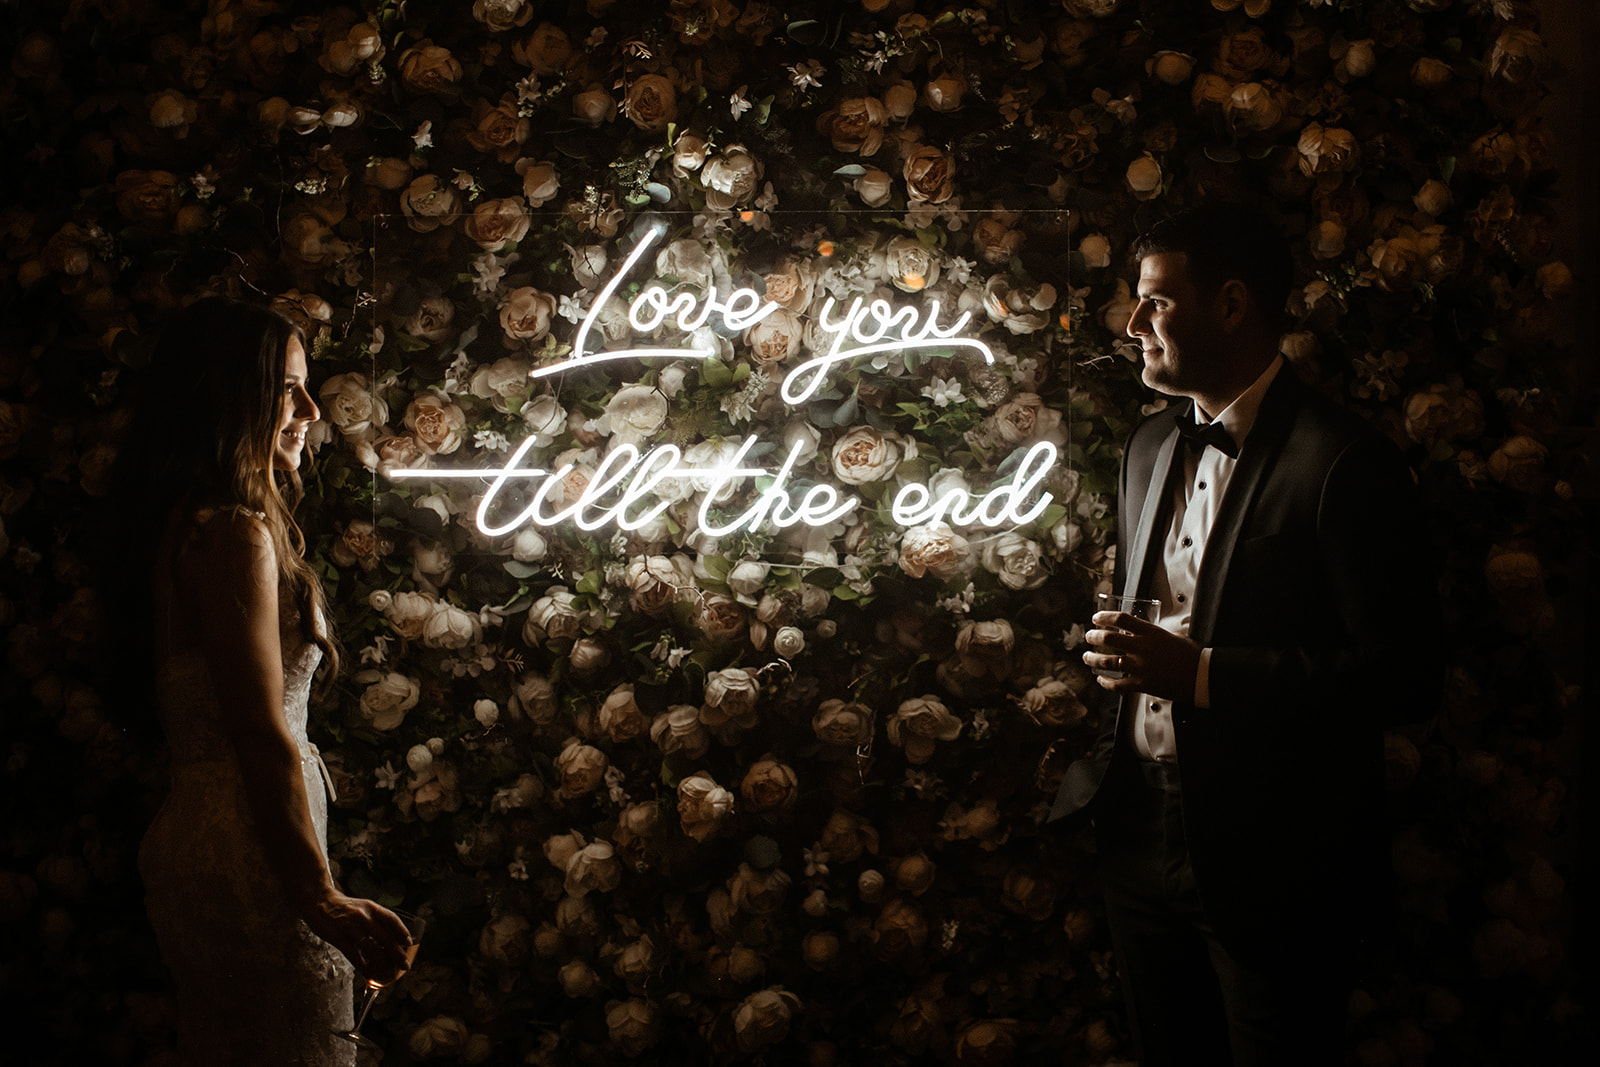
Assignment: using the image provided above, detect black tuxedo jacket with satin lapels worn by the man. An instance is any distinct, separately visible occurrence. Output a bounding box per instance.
[1051,366,1438,952]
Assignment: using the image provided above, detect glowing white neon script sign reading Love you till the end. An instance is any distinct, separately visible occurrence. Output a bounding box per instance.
[389,230,1058,537]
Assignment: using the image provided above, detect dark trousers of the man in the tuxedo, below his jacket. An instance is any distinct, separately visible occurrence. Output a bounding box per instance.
[1094,763,1349,1067]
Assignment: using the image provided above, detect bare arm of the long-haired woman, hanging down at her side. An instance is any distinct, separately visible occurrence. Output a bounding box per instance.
[181,512,408,977]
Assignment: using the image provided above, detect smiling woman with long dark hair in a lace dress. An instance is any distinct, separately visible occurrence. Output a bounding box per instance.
[122,298,410,1067]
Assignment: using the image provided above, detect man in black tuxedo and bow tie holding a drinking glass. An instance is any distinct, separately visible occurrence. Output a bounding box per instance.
[1051,205,1438,1067]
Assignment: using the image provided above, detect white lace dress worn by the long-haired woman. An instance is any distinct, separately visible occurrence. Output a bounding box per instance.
[139,627,355,1067]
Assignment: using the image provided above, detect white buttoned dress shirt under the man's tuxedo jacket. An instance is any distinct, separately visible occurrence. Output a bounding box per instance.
[1133,357,1283,763]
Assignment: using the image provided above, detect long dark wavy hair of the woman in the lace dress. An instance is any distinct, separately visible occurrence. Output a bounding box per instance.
[115,296,339,694]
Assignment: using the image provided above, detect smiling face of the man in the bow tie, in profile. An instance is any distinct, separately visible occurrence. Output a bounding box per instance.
[1128,253,1221,397]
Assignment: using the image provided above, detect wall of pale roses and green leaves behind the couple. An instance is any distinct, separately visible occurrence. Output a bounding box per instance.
[0,0,1592,1064]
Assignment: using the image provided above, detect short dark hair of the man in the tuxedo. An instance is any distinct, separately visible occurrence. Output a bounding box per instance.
[1133,203,1294,328]
